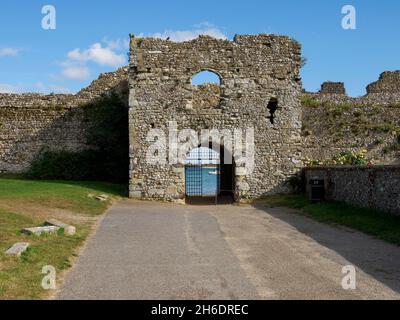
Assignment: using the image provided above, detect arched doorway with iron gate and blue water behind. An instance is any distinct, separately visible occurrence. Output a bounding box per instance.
[185,145,235,203]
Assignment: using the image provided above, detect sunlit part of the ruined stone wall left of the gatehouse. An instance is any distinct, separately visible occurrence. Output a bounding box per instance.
[0,68,127,172]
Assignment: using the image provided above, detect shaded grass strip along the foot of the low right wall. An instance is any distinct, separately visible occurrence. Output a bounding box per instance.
[253,195,400,245]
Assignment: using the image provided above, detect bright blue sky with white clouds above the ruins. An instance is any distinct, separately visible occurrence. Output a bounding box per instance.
[0,0,400,96]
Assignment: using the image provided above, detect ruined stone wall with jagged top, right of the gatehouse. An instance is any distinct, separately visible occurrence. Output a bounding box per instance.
[302,71,400,164]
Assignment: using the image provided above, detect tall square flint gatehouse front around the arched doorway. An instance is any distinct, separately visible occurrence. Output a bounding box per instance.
[129,35,301,200]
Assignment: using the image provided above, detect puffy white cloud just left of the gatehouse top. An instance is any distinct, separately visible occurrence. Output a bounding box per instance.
[68,43,126,67]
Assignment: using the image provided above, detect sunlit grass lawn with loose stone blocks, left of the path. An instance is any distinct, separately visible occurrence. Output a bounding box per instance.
[0,176,124,300]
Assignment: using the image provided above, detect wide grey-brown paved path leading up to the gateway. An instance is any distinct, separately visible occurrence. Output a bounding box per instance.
[57,200,400,299]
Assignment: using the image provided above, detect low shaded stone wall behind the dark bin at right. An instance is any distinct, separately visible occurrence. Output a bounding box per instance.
[304,166,400,216]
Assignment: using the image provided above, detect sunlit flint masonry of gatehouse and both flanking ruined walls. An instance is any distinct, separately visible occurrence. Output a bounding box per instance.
[0,31,400,201]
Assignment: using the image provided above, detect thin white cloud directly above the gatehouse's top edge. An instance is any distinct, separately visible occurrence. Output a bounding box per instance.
[139,22,227,42]
